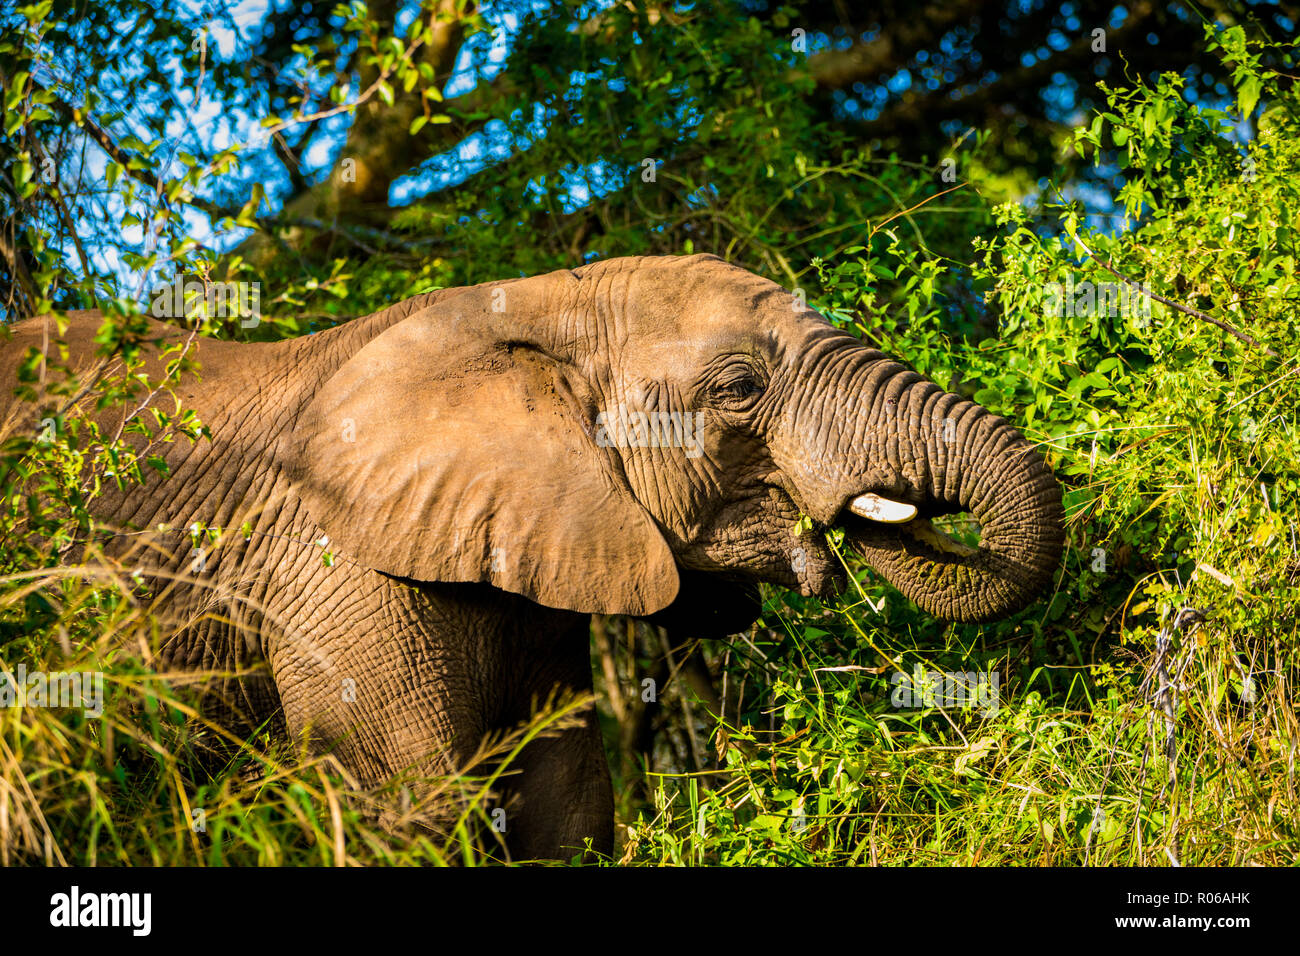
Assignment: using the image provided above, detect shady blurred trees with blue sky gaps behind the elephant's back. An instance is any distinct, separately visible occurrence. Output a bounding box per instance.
[0,0,1297,325]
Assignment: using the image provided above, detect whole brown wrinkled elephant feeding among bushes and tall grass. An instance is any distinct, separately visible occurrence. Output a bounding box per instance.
[0,255,1063,860]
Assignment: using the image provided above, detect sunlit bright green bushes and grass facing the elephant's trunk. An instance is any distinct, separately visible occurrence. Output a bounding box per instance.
[628,30,1300,865]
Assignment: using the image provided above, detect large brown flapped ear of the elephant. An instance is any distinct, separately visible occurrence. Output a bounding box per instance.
[286,280,677,615]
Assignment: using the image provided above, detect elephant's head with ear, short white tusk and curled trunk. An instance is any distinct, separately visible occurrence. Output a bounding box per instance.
[286,256,1063,631]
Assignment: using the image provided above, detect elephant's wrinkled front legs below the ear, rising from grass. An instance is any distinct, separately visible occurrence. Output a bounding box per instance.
[268,581,614,858]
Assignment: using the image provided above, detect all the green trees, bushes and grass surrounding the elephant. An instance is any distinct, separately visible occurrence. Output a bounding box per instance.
[0,0,1300,865]
